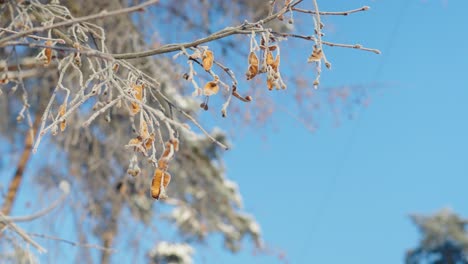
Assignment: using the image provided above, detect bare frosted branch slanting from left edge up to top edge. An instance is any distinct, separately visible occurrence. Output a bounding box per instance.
[0,0,159,47]
